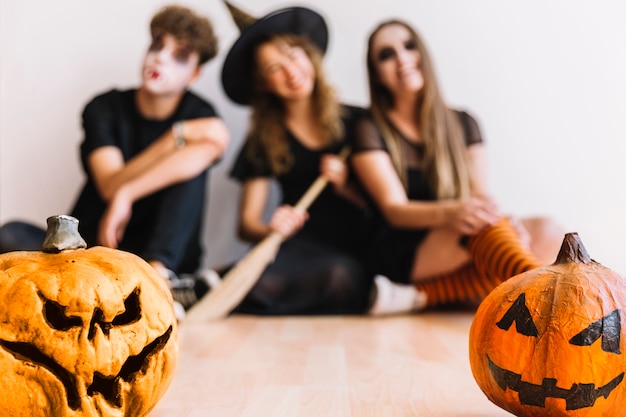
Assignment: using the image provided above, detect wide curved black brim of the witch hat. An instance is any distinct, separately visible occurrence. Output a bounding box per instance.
[222,7,328,105]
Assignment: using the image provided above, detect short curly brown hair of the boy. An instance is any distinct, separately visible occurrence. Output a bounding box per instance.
[150,5,218,65]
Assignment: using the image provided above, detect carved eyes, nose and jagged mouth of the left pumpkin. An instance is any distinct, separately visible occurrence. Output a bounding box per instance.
[0,289,172,410]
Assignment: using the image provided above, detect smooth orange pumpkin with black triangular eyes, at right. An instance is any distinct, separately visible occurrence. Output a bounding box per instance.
[470,234,626,417]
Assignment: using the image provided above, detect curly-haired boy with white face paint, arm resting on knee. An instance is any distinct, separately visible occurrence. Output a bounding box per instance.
[0,6,229,316]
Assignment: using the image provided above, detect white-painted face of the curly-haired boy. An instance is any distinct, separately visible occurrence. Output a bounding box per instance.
[142,34,200,95]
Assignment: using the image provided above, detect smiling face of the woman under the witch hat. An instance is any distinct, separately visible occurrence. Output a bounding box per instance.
[256,41,315,101]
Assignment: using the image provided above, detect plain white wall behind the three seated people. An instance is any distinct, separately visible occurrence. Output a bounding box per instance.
[0,0,626,274]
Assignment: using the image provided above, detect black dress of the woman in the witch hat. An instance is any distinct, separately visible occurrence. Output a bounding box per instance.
[231,106,372,314]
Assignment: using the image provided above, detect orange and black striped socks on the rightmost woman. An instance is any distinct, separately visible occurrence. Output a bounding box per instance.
[415,218,541,307]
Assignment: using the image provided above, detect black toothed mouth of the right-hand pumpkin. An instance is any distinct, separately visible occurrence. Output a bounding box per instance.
[487,356,624,410]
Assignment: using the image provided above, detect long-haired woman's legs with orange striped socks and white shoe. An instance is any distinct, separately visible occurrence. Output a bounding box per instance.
[370,218,561,314]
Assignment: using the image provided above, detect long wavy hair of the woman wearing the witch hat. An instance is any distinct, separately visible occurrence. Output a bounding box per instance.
[248,34,344,175]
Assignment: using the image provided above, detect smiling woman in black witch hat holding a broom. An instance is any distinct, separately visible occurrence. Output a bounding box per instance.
[216,6,372,315]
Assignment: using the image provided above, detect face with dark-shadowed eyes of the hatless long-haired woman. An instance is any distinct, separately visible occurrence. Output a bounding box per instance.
[371,24,424,94]
